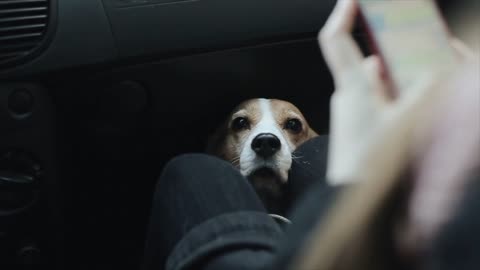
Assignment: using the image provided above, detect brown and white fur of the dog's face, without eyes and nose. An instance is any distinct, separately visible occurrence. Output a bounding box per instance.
[208,99,317,182]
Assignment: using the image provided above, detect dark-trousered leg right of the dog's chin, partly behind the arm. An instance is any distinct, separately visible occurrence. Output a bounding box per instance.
[265,135,341,270]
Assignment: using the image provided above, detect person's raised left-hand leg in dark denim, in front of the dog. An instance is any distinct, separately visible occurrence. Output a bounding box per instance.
[143,155,282,270]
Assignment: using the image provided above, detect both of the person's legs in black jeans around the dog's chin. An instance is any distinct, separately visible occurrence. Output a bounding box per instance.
[143,136,333,270]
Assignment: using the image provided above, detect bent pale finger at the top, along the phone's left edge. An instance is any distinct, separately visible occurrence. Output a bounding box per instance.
[319,0,363,82]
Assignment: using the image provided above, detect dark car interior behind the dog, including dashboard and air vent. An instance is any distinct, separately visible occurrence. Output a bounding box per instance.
[0,0,458,270]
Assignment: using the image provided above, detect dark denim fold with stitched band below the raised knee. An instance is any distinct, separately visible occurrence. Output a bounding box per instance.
[166,211,283,270]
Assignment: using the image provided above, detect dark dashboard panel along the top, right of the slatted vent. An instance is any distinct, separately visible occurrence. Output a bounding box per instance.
[0,0,335,79]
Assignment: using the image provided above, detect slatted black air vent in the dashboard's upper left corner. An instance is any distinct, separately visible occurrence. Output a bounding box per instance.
[0,0,50,67]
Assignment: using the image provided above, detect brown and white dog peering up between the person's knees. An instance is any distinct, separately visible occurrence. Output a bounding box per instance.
[207,99,318,212]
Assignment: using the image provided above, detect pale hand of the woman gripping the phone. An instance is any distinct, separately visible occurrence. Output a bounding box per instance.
[319,0,448,185]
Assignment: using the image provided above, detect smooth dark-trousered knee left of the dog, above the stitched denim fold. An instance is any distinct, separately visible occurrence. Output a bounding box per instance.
[144,154,265,269]
